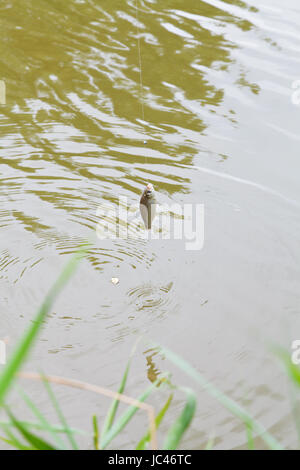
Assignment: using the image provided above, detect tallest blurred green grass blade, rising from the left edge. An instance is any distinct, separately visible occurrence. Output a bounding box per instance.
[0,254,80,405]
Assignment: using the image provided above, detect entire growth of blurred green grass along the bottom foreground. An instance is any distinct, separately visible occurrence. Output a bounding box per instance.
[0,255,300,450]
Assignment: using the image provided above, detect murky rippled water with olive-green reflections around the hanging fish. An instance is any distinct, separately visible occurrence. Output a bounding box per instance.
[0,0,300,448]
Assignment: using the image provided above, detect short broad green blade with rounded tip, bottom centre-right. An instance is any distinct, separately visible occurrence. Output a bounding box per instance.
[163,388,197,450]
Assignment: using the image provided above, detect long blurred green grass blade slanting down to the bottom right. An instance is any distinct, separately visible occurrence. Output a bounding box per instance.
[155,345,283,450]
